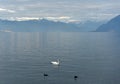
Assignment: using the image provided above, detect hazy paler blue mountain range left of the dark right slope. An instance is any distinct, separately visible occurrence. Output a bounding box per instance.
[0,19,102,32]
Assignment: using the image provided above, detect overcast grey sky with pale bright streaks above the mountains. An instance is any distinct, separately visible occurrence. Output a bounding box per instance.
[0,0,120,22]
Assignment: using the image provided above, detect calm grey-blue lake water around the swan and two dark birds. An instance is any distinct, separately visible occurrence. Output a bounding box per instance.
[0,33,120,84]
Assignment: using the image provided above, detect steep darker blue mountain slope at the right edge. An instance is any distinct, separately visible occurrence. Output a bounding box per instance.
[96,15,120,32]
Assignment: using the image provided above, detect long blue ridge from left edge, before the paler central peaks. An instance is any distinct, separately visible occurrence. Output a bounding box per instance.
[0,19,82,32]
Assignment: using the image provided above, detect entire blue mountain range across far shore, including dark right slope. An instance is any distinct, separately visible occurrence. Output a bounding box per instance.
[0,15,120,32]
